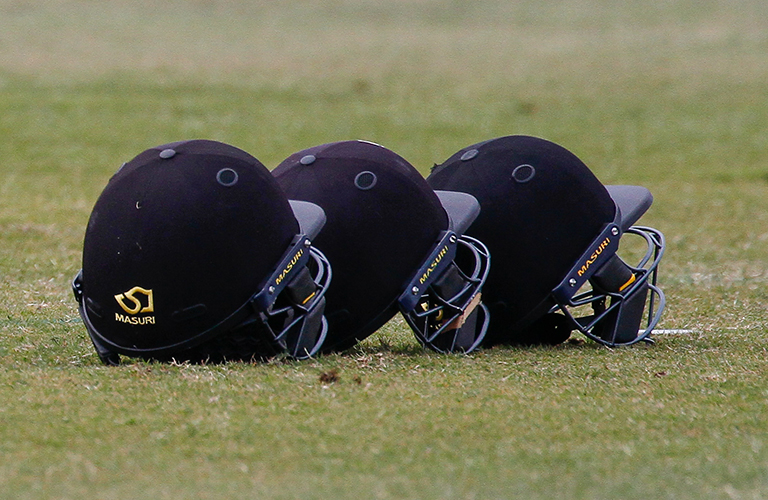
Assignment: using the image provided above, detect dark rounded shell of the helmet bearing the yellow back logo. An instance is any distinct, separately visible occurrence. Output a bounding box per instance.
[82,140,299,352]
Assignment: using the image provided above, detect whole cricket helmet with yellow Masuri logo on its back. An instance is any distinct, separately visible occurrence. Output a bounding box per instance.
[73,140,331,364]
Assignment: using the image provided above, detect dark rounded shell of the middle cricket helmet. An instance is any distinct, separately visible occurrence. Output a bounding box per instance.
[272,141,448,351]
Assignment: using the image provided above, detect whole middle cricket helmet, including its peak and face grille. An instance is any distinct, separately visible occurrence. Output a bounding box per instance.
[272,141,489,352]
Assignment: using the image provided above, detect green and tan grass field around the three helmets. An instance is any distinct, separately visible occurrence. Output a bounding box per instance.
[0,0,768,499]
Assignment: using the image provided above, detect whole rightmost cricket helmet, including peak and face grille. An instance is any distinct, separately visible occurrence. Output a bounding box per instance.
[427,136,665,346]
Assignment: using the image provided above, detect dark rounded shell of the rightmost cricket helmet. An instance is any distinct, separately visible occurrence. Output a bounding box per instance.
[427,135,616,344]
